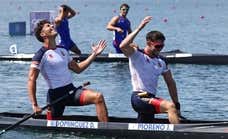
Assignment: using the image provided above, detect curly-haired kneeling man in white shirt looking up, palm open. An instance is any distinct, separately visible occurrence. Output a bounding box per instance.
[28,20,108,122]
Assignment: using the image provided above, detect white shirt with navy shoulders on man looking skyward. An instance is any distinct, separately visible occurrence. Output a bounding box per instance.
[31,47,72,89]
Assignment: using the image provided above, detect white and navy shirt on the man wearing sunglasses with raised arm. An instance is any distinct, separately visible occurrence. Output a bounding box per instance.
[129,50,169,95]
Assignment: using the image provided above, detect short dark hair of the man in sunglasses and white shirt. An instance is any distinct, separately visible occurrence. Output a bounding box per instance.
[146,30,165,41]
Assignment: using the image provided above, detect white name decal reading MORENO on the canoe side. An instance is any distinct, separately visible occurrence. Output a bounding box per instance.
[128,123,174,131]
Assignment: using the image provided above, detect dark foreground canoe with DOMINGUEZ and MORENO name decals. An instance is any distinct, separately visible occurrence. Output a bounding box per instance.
[0,113,228,139]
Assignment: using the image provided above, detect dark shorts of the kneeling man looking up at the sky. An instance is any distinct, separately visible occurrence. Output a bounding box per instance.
[47,84,83,118]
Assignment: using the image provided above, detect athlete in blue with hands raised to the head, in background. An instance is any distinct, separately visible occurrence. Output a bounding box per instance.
[55,5,81,55]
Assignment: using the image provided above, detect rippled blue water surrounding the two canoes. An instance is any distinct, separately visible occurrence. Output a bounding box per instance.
[0,0,228,139]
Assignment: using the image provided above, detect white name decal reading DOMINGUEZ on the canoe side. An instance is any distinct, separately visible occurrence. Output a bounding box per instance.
[47,120,98,129]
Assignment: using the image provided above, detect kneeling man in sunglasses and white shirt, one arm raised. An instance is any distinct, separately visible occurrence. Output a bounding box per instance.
[120,16,180,124]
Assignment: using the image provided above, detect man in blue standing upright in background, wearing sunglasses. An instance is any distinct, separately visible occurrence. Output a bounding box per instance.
[107,3,131,53]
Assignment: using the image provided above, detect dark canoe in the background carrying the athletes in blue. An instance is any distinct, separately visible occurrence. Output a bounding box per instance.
[0,50,228,65]
